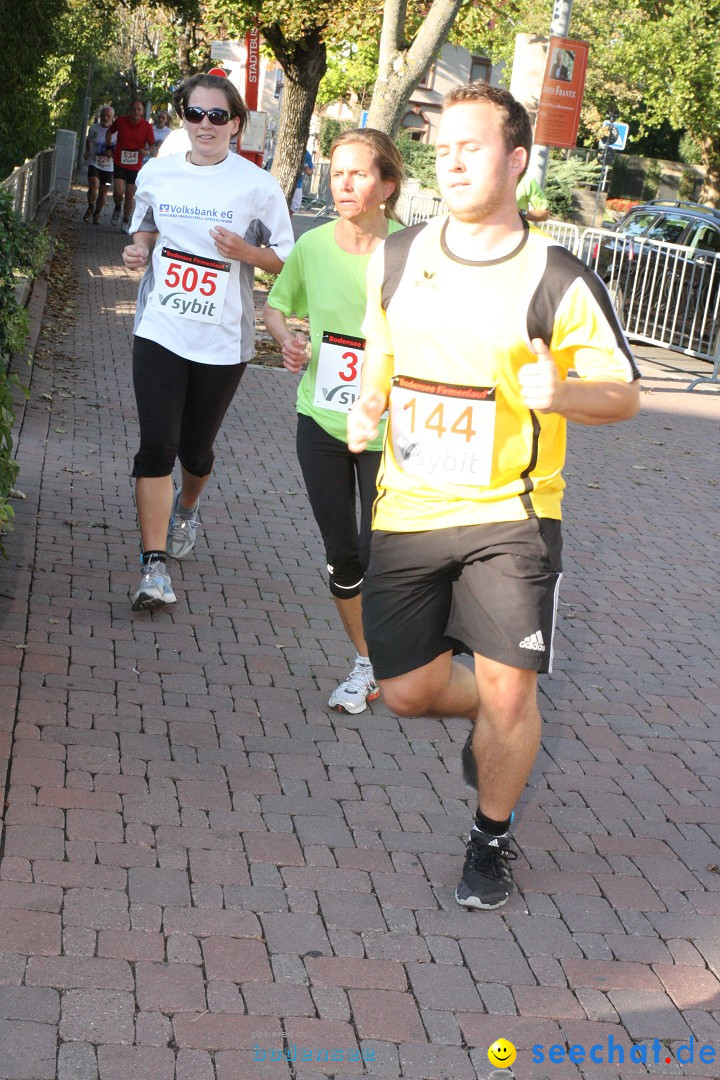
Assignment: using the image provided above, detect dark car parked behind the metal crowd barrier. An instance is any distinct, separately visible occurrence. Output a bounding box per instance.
[581,200,720,355]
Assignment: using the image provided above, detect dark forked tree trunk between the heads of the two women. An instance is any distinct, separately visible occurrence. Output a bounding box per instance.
[261,23,327,204]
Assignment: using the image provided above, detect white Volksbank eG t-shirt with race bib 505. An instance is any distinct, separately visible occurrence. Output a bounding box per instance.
[131,153,293,364]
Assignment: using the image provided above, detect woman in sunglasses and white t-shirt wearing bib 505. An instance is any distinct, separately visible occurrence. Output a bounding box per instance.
[123,75,293,611]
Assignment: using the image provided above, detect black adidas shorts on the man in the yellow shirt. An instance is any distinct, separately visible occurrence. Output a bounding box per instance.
[363,517,562,678]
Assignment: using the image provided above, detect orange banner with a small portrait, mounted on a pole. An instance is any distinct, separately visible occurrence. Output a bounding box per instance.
[534,37,589,147]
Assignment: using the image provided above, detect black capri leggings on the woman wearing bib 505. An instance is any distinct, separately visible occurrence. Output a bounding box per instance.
[133,337,246,476]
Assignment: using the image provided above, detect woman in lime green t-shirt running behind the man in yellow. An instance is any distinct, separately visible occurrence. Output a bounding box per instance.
[263,129,404,713]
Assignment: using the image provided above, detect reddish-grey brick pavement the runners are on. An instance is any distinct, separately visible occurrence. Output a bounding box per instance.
[0,187,720,1080]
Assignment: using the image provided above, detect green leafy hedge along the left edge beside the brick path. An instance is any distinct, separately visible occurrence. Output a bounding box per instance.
[0,188,47,554]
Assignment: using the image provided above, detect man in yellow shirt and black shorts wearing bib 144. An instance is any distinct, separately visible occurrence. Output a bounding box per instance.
[348,83,639,908]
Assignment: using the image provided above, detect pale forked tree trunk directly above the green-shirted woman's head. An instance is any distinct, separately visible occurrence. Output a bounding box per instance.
[367,0,463,135]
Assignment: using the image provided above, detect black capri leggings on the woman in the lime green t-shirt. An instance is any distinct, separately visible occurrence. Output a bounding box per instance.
[297,414,380,599]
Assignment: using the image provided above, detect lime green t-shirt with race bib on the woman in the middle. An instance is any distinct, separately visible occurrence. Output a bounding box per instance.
[268,221,403,450]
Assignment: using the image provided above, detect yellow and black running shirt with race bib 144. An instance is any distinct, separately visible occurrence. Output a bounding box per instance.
[363,218,639,532]
